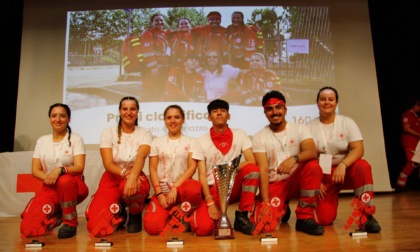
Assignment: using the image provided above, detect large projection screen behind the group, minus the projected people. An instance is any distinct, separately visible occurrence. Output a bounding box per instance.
[15,0,391,191]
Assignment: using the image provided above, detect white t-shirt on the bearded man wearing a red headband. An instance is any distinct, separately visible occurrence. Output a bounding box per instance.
[252,122,312,182]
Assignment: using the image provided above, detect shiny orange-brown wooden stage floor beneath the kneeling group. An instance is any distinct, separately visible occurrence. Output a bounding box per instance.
[0,191,420,252]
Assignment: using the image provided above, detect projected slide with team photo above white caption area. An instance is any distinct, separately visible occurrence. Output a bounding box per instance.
[64,6,334,144]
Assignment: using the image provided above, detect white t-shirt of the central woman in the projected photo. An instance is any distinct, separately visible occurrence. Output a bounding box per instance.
[201,65,241,101]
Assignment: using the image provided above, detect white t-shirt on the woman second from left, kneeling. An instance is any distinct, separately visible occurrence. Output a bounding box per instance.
[99,126,153,169]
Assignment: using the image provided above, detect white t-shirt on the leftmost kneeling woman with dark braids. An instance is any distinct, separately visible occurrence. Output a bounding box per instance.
[32,132,86,173]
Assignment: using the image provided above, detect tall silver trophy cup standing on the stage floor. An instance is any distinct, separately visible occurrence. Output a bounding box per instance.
[213,154,242,240]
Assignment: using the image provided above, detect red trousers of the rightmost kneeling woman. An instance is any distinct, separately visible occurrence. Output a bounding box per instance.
[316,159,376,226]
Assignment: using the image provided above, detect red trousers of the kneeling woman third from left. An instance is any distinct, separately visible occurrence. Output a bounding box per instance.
[143,179,202,235]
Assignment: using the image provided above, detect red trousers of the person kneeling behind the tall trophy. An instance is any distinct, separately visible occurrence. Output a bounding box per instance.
[190,164,260,236]
